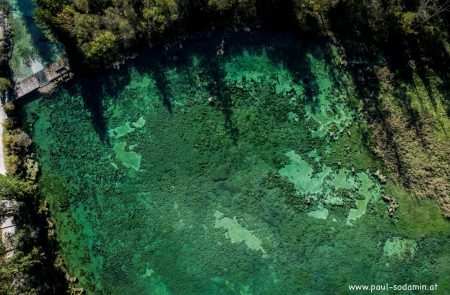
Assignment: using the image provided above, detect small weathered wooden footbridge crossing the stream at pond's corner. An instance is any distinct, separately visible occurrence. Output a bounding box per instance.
[14,59,70,99]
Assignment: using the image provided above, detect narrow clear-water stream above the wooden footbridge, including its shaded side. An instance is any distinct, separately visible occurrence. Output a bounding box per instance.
[7,0,64,81]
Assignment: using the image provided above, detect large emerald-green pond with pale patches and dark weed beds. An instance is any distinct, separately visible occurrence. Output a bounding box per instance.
[23,33,450,294]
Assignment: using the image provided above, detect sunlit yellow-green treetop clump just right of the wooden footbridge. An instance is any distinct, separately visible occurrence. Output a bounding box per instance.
[36,0,179,62]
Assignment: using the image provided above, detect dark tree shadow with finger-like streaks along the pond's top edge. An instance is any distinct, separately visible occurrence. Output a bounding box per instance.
[41,31,348,143]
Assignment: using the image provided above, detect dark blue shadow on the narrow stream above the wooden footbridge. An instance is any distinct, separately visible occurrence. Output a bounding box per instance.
[15,0,61,63]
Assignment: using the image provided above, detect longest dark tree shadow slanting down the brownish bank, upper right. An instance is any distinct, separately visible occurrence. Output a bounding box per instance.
[329,2,404,174]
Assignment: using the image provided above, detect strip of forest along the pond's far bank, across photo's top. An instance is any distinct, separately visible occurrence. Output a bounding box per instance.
[36,0,450,63]
